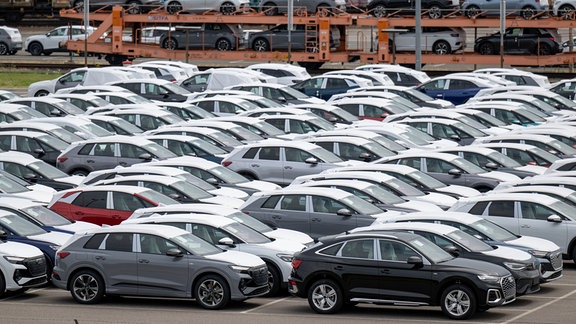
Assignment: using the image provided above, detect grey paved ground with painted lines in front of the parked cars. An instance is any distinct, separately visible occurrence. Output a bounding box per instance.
[0,261,576,324]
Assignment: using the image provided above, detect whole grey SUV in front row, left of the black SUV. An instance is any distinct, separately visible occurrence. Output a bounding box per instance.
[52,225,269,309]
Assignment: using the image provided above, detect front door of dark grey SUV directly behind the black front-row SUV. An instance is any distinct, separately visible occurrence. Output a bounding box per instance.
[308,195,359,237]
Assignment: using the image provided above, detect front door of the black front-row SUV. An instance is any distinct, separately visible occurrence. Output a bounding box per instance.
[378,239,435,303]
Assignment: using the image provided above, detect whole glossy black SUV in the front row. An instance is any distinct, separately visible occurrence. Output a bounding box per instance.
[288,232,516,319]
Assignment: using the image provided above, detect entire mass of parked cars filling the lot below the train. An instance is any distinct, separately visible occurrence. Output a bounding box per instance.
[0,62,576,319]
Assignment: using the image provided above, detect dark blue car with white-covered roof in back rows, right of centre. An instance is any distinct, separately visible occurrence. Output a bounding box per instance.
[416,75,494,105]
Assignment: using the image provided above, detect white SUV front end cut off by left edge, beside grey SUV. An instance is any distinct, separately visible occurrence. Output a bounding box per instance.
[0,231,48,296]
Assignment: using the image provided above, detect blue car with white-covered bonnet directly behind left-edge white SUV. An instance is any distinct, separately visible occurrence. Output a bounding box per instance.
[0,210,72,274]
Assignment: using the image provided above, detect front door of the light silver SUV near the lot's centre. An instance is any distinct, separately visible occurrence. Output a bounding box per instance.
[281,147,326,185]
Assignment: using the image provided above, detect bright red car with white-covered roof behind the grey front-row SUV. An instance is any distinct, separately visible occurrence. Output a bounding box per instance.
[48,185,178,225]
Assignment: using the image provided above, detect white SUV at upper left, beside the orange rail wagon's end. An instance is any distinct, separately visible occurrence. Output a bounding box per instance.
[24,25,96,56]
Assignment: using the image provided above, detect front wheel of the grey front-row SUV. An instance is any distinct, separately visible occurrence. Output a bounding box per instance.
[194,275,230,309]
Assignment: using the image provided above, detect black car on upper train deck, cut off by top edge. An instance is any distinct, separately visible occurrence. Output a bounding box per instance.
[367,0,460,19]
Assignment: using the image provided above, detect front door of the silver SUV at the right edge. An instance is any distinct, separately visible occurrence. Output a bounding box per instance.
[516,201,573,250]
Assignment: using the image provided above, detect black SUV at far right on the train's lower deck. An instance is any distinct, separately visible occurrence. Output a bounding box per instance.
[474,27,562,55]
